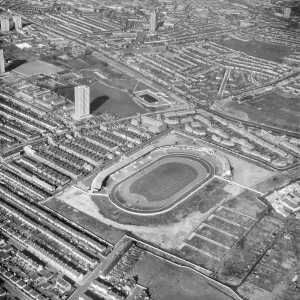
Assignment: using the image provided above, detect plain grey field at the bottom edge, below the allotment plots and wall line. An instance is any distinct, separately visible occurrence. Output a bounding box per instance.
[131,253,239,300]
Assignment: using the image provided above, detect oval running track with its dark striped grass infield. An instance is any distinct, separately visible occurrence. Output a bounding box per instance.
[110,155,214,213]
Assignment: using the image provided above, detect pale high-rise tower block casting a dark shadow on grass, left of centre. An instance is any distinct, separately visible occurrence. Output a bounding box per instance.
[75,85,90,117]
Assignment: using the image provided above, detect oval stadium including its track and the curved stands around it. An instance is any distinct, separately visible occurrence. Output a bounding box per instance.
[106,146,230,215]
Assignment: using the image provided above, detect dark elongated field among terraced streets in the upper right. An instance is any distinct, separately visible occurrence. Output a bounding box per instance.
[221,38,289,62]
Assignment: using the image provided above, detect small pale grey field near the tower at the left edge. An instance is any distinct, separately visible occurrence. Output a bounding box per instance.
[14,59,63,76]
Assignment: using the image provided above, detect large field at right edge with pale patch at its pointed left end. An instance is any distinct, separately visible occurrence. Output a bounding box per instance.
[212,92,300,131]
